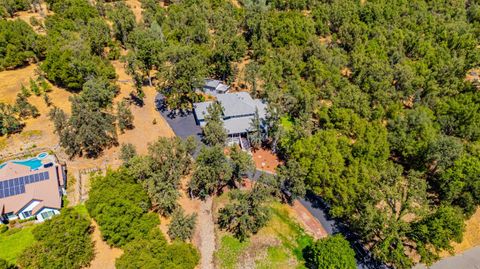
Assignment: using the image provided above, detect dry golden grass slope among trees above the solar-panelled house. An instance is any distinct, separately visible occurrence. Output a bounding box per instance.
[0,62,174,175]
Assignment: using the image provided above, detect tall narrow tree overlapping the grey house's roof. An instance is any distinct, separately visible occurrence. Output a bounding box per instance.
[203,102,227,146]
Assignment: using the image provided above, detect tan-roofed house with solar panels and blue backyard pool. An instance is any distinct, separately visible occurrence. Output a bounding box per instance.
[0,153,66,222]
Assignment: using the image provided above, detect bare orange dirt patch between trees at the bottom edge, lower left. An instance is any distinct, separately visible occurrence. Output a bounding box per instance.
[88,220,123,269]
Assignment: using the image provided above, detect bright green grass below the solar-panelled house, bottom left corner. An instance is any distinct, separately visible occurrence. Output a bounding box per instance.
[0,225,35,264]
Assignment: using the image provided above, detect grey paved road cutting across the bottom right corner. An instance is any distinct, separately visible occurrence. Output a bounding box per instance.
[414,247,480,269]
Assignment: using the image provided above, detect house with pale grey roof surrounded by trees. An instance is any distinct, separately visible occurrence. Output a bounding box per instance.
[193,92,267,147]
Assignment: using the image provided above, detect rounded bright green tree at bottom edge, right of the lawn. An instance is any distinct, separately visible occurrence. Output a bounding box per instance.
[306,234,357,269]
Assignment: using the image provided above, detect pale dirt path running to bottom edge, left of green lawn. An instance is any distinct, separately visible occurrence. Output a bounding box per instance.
[197,197,215,269]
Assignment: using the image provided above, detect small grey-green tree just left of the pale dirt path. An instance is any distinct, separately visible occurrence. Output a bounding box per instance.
[167,208,197,241]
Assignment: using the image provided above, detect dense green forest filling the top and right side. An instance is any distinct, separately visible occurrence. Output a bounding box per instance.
[0,0,480,268]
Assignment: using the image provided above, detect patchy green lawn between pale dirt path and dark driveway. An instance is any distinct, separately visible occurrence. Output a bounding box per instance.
[215,198,313,269]
